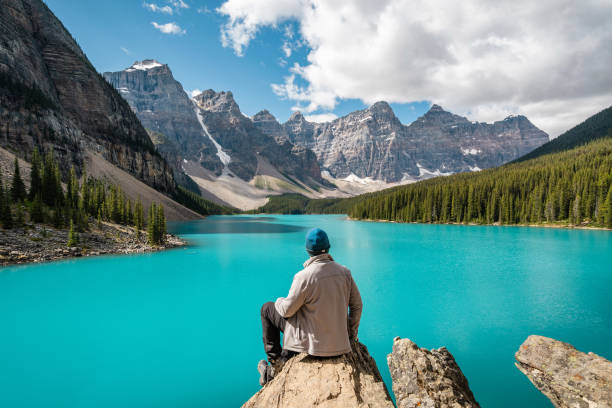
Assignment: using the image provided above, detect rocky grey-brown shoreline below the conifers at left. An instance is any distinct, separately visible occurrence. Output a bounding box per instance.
[0,222,187,266]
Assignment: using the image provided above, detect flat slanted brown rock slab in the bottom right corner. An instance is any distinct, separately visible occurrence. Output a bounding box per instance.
[515,336,612,408]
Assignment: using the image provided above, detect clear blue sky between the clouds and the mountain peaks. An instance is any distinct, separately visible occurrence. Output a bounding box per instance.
[46,0,430,123]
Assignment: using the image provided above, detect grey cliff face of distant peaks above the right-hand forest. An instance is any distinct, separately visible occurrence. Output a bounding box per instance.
[282,102,548,182]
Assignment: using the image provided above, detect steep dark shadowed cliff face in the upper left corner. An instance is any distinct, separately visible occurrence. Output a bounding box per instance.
[0,0,174,191]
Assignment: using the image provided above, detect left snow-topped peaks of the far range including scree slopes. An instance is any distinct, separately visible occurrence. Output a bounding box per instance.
[104,60,331,209]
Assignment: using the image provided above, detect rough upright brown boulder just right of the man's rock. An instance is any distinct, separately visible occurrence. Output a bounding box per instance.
[387,337,479,408]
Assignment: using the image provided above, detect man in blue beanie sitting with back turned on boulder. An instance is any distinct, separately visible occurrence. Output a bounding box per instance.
[257,228,362,386]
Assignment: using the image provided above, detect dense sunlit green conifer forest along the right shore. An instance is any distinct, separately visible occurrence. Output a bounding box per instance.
[348,138,612,228]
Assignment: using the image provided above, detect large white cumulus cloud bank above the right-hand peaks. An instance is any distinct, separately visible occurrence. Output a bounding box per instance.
[217,0,612,136]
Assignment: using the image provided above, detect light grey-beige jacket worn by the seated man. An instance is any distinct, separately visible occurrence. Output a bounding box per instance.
[274,254,362,357]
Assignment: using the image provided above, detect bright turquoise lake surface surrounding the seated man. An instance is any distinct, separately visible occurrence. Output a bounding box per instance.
[0,216,612,408]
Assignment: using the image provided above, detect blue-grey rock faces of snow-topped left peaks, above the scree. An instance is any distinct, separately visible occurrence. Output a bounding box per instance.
[104,60,326,186]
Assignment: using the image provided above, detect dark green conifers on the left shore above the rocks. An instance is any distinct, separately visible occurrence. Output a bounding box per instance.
[0,150,166,245]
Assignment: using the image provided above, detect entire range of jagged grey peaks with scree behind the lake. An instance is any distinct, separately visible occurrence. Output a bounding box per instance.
[104,60,548,208]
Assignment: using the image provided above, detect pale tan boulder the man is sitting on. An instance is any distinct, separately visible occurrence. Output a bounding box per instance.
[242,343,393,408]
